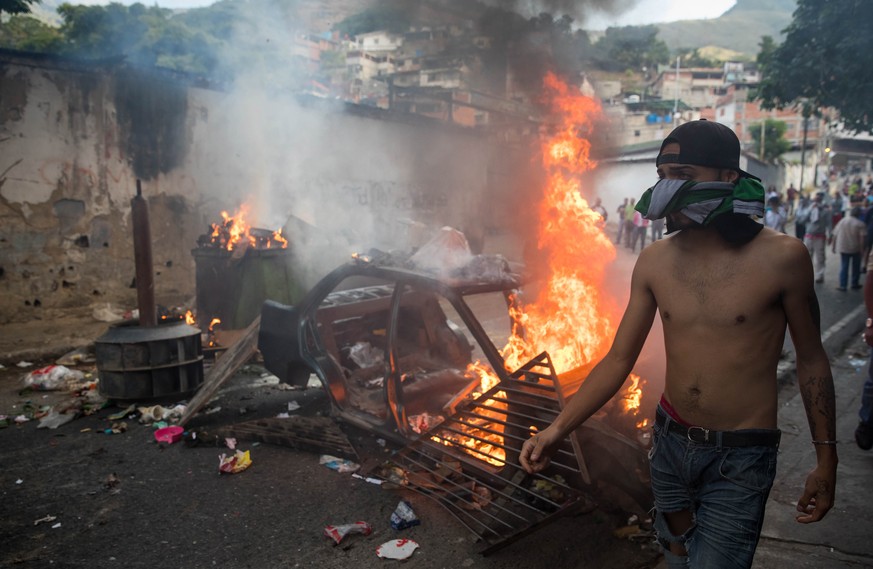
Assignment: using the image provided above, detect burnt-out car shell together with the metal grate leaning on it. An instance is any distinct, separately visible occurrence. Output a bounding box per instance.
[258,246,650,554]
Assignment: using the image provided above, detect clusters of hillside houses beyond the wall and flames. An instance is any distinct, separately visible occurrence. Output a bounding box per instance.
[292,23,824,178]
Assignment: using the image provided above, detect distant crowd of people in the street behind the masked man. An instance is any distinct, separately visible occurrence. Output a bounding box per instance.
[592,174,873,291]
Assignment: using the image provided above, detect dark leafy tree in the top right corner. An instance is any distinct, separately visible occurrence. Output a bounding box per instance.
[758,0,873,132]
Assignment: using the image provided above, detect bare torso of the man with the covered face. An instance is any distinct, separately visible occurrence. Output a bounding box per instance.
[641,226,791,430]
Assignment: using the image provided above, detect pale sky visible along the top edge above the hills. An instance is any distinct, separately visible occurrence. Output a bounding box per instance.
[66,0,736,30]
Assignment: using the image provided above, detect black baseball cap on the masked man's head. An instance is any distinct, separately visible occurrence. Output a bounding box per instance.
[656,119,760,181]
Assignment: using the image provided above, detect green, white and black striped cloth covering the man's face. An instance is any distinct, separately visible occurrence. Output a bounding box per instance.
[634,178,764,225]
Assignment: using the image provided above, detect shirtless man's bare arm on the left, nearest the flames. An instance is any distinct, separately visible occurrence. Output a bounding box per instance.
[519,248,658,473]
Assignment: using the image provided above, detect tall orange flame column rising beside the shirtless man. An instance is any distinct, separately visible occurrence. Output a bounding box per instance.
[502,74,615,374]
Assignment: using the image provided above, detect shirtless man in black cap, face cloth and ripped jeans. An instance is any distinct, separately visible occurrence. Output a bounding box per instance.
[520,121,837,569]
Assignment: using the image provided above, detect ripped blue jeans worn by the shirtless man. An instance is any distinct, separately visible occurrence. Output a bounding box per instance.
[649,406,778,569]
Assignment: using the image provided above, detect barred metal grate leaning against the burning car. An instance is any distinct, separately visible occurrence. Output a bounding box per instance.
[383,352,590,555]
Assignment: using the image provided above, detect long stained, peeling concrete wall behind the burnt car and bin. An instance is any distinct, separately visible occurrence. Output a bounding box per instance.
[0,52,530,323]
